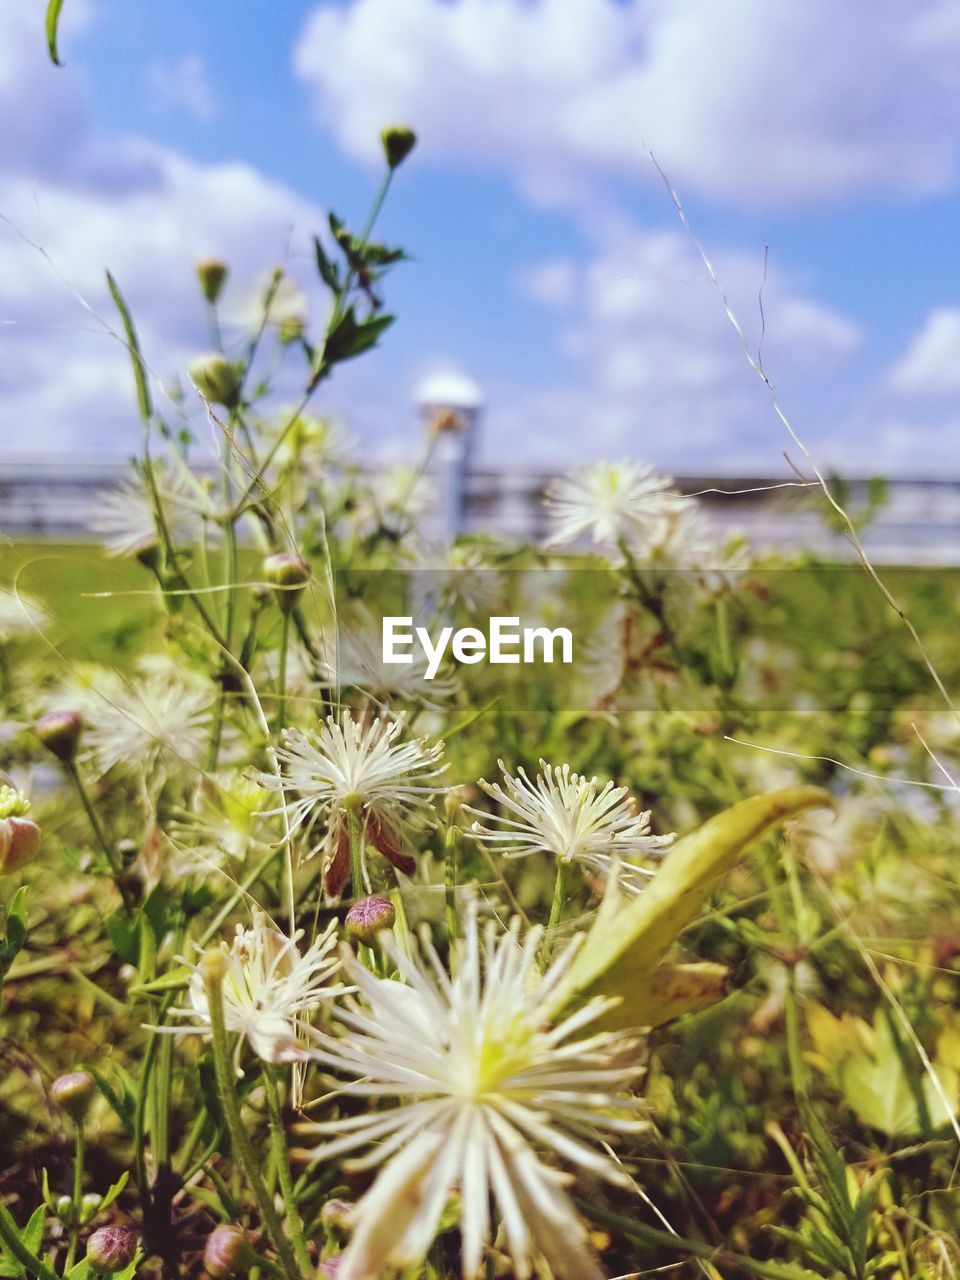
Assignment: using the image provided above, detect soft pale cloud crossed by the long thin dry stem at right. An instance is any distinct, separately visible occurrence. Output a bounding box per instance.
[498,229,863,470]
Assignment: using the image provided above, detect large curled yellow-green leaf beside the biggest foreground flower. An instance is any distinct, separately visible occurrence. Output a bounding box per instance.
[554,787,832,1027]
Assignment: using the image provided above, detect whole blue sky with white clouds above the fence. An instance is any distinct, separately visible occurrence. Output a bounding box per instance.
[0,0,960,474]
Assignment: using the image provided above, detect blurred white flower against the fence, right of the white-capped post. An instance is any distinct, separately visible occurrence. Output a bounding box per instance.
[547,461,681,549]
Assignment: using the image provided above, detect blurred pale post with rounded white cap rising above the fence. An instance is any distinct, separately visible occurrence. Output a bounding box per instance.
[416,371,484,541]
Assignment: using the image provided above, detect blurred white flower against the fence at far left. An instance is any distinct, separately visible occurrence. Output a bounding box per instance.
[90,463,202,556]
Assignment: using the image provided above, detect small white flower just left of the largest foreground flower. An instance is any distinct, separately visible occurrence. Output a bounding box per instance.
[171,911,344,1062]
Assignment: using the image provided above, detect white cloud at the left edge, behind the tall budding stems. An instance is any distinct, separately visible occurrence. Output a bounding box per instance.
[0,5,332,454]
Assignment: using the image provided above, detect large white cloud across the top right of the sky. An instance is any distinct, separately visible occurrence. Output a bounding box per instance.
[294,0,960,209]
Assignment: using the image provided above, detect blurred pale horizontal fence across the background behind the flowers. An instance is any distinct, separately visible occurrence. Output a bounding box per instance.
[0,461,960,564]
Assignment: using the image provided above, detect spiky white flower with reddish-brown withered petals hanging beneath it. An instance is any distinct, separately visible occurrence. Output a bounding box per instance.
[259,712,445,896]
